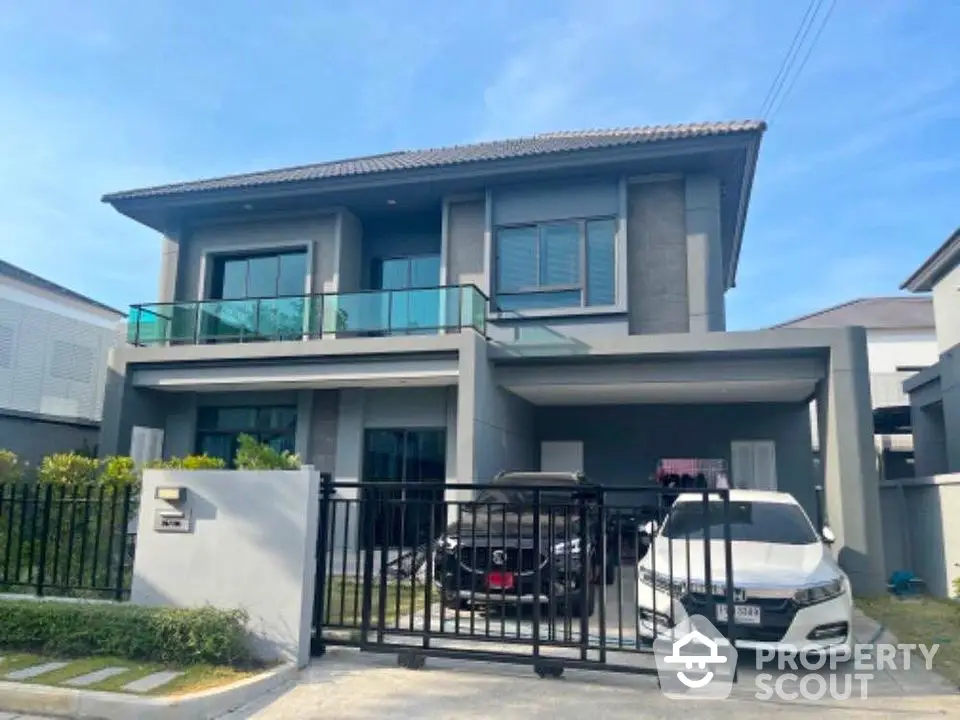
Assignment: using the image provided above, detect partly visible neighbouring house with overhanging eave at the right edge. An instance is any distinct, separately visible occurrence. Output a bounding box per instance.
[902,228,960,477]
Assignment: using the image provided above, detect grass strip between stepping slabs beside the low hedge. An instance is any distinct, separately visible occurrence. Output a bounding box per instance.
[0,648,261,695]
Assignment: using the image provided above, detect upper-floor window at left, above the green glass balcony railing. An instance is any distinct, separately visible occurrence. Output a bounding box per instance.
[210,250,307,300]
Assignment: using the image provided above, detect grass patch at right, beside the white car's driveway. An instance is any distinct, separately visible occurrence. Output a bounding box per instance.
[857,596,960,687]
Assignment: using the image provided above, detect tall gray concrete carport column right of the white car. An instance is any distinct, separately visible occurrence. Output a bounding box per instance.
[817,327,886,595]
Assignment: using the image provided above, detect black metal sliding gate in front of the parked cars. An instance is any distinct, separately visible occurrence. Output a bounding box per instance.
[312,476,742,676]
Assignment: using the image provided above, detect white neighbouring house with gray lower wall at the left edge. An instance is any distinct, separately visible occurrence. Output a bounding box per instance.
[0,261,124,464]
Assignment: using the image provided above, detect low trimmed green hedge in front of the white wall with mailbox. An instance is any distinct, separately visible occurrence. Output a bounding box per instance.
[0,601,252,666]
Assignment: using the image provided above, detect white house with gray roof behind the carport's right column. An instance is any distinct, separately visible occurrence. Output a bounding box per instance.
[775,296,937,479]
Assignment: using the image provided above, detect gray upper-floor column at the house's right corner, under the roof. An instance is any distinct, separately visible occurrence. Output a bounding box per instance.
[684,175,726,333]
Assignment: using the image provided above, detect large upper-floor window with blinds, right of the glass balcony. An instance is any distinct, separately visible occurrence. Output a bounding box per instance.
[496,218,616,310]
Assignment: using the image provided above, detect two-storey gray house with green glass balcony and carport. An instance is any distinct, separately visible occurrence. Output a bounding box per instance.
[101,122,884,592]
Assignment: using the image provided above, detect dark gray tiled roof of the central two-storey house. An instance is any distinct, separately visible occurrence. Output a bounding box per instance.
[103,120,766,203]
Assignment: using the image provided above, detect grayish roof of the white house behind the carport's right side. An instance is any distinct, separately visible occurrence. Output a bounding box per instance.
[774,295,934,330]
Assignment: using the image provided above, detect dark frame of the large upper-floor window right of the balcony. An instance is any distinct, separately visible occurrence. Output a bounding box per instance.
[491,215,619,311]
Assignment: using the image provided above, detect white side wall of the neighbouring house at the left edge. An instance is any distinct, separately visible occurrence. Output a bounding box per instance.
[0,278,121,422]
